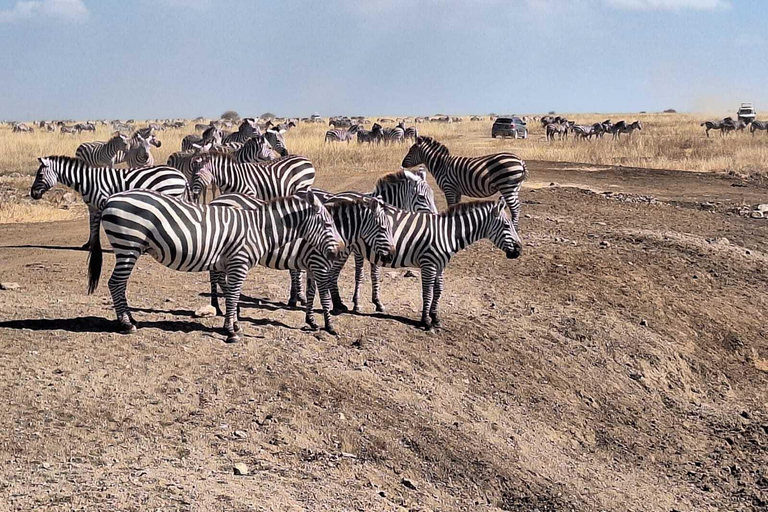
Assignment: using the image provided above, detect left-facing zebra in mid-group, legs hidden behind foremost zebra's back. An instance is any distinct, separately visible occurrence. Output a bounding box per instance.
[192,152,315,201]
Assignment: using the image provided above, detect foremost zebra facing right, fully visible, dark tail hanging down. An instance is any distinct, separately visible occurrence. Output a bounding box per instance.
[83,190,344,343]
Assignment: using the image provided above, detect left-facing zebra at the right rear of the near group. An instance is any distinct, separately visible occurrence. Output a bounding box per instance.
[402,137,528,229]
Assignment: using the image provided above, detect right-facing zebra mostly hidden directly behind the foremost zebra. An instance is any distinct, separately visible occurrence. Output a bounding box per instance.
[210,194,393,335]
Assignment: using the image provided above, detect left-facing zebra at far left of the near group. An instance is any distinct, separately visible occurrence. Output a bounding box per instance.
[30,156,189,249]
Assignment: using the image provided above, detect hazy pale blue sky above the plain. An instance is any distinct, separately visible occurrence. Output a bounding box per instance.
[0,0,768,120]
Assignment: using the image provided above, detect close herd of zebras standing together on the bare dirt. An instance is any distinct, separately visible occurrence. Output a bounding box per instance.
[30,124,527,342]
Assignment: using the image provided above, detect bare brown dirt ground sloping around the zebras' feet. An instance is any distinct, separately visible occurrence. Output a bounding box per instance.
[0,162,768,512]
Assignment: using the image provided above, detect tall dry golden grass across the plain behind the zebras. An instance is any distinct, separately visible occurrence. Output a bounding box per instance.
[0,114,768,222]
